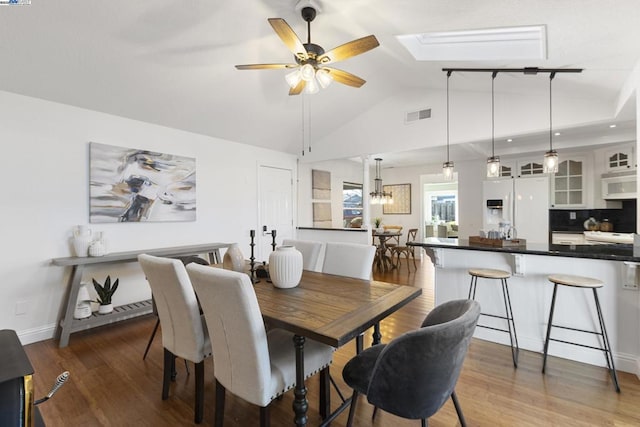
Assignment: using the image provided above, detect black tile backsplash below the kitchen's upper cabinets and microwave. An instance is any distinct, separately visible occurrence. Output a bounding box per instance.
[549,200,637,233]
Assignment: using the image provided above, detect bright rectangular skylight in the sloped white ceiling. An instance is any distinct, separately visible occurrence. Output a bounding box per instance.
[396,25,547,61]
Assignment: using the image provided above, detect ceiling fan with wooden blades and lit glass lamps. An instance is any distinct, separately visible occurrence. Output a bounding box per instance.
[236,2,379,95]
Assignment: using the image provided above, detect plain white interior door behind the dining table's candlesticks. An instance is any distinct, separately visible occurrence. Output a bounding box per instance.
[256,165,293,261]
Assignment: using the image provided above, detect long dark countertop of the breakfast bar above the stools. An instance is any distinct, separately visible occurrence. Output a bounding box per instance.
[408,237,640,262]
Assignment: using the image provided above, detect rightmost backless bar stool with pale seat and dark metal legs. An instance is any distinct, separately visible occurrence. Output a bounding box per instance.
[542,274,620,393]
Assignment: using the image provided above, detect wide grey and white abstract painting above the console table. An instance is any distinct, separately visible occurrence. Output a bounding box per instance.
[89,142,196,223]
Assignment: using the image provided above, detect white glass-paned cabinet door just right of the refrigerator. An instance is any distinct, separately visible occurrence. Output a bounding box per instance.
[551,156,587,208]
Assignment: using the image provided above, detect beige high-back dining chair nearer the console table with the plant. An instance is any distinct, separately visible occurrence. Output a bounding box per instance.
[138,254,211,424]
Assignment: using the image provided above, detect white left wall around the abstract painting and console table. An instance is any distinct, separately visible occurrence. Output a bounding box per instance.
[0,92,296,343]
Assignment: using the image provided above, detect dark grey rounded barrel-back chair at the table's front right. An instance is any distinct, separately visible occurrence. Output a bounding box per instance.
[342,300,480,427]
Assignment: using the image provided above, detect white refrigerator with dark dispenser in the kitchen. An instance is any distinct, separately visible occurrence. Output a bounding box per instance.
[482,175,549,243]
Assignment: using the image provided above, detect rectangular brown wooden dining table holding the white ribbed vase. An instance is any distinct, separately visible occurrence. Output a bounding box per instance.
[255,271,422,426]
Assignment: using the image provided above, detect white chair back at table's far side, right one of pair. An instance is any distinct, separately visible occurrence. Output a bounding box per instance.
[322,242,376,280]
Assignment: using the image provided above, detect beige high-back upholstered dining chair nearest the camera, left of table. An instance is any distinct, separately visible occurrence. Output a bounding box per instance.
[187,264,334,427]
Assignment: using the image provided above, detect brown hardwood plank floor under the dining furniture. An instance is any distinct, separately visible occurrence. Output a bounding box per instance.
[26,260,640,427]
